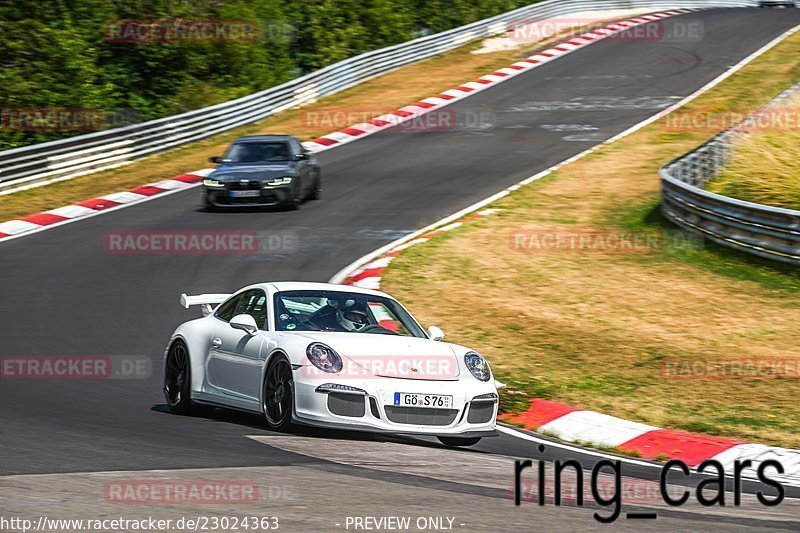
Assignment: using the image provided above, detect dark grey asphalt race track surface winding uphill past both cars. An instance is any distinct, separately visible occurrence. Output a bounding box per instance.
[0,9,800,527]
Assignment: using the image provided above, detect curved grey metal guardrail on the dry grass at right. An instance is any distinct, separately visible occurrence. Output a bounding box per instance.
[660,84,800,265]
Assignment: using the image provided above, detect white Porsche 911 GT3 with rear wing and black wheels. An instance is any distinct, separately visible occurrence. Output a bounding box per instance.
[164,282,498,446]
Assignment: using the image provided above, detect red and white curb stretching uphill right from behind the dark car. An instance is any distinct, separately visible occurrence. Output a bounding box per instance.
[303,8,697,152]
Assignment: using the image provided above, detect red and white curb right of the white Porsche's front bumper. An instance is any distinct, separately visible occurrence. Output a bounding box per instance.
[503,399,800,485]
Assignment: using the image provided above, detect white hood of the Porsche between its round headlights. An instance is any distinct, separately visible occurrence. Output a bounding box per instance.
[294,331,460,381]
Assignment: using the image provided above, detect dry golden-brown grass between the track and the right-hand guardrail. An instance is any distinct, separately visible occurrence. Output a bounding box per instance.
[383,31,800,447]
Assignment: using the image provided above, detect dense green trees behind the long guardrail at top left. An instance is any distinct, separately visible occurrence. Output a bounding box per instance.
[0,0,528,150]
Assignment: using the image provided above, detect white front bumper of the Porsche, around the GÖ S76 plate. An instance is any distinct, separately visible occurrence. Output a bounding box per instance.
[294,370,498,437]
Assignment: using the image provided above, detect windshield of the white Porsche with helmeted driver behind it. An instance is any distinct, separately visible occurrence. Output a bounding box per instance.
[275,290,427,338]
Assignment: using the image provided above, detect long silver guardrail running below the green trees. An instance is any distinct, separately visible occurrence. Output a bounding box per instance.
[0,0,757,194]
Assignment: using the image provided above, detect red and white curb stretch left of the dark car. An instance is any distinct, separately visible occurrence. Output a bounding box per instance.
[0,168,214,241]
